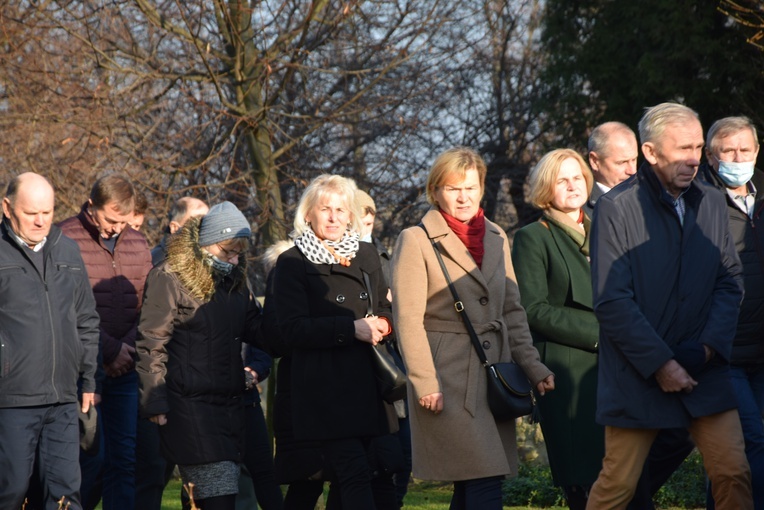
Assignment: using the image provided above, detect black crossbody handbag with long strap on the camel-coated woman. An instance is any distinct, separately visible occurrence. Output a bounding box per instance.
[419,223,538,422]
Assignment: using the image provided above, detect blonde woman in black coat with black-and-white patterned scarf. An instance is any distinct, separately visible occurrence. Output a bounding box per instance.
[272,175,394,509]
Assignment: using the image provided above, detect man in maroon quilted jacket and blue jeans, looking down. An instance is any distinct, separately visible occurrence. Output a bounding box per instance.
[60,174,152,510]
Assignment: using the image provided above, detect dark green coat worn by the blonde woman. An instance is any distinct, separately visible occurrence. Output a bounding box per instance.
[512,219,605,487]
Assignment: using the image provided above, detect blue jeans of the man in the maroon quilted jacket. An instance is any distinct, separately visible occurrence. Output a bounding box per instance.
[80,370,138,510]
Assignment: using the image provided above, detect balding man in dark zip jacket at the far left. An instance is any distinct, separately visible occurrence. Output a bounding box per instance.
[0,172,99,509]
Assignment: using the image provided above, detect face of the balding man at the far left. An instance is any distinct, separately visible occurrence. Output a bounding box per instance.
[3,183,54,248]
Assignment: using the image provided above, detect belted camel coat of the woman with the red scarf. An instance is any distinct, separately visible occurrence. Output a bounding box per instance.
[392,209,551,480]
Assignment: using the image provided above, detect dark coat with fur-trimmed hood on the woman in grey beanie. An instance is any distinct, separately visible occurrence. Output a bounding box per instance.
[136,219,261,465]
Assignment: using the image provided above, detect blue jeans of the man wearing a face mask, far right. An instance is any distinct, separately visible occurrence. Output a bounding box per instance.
[707,366,764,510]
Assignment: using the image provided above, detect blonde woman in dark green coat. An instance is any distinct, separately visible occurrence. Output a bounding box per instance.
[512,149,604,510]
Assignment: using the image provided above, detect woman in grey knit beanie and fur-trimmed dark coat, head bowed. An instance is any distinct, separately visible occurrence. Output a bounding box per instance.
[136,202,260,510]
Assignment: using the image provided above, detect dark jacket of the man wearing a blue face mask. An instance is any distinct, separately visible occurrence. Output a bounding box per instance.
[698,163,764,366]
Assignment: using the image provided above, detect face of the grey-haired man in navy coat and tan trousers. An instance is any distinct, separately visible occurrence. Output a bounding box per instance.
[642,119,703,197]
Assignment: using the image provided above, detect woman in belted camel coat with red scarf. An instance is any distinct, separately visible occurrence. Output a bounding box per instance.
[392,147,554,509]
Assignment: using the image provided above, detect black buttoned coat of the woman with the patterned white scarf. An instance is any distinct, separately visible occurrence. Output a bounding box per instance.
[269,243,392,441]
